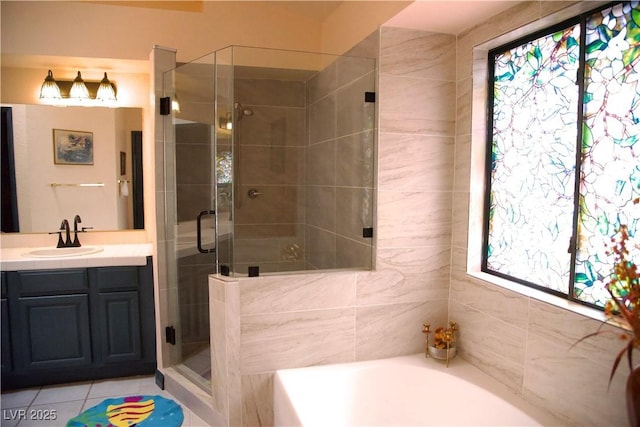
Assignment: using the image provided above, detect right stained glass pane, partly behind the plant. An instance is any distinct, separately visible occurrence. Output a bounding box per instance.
[574,2,640,306]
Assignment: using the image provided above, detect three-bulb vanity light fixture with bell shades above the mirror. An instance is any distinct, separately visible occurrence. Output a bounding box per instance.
[40,70,117,106]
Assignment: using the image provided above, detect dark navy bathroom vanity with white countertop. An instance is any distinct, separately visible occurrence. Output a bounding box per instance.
[0,245,156,389]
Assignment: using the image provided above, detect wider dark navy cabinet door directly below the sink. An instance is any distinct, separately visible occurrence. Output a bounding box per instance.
[12,295,92,370]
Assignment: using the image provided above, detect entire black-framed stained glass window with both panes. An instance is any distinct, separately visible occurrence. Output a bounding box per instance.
[482,1,640,308]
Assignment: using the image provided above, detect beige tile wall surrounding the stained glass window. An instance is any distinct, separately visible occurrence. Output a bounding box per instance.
[449,1,628,426]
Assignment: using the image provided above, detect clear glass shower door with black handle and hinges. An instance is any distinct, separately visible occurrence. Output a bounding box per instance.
[164,55,216,391]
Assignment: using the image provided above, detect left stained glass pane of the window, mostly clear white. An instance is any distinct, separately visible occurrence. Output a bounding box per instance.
[485,25,580,293]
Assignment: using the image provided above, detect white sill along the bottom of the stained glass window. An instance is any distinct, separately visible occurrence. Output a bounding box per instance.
[467,271,628,329]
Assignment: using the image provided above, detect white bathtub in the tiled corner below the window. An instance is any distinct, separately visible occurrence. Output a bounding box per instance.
[273,354,562,427]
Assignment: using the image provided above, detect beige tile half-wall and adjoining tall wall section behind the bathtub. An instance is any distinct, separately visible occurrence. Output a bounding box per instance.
[210,28,455,426]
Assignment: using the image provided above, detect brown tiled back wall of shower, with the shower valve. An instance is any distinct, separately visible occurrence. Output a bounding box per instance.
[234,66,307,274]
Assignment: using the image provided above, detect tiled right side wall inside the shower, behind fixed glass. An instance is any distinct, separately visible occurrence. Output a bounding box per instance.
[305,57,375,270]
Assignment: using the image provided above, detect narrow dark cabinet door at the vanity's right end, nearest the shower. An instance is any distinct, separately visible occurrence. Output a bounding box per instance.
[98,291,142,363]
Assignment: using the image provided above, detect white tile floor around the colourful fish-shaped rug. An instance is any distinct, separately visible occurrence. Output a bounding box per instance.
[0,376,214,427]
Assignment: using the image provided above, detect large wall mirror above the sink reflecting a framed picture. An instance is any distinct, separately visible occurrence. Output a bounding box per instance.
[2,104,144,233]
